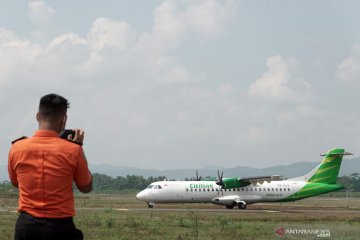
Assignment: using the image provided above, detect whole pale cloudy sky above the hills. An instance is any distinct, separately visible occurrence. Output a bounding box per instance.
[0,0,360,170]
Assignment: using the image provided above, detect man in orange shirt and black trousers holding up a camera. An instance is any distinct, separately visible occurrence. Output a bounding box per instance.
[8,94,92,240]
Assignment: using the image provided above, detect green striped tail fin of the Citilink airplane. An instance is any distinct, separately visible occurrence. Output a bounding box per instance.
[308,148,351,184]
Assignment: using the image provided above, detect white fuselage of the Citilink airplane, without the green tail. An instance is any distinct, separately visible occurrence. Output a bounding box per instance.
[136,180,305,205]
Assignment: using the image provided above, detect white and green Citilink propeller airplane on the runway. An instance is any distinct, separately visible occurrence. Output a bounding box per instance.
[136,148,353,209]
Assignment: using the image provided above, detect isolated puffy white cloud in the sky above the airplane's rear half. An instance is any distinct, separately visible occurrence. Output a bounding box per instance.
[249,55,310,101]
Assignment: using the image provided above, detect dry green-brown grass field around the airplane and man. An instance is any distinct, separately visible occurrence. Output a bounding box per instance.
[0,193,360,240]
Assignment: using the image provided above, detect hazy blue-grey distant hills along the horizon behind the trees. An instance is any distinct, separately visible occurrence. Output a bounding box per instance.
[0,158,360,181]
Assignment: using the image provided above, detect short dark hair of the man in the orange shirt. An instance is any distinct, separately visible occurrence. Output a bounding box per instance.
[39,93,70,119]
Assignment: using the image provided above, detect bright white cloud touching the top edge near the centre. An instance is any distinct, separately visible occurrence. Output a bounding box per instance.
[137,0,236,52]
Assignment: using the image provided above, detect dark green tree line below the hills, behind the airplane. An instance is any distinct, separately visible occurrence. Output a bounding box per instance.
[0,173,360,193]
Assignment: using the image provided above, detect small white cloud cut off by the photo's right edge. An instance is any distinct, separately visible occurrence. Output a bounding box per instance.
[336,45,360,83]
